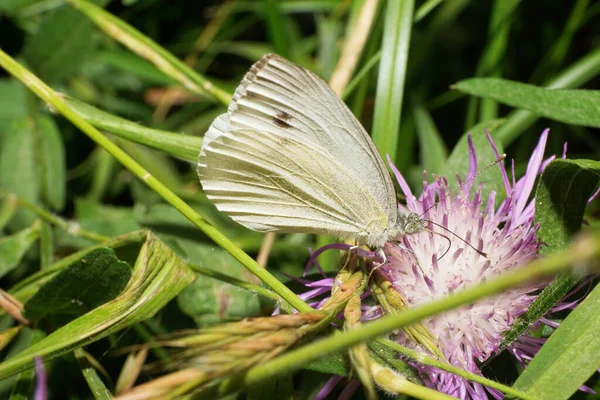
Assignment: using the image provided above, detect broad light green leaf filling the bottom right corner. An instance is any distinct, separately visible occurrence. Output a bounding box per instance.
[514,286,600,399]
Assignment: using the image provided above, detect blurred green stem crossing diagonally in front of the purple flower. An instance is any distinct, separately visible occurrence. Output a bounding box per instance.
[219,231,600,395]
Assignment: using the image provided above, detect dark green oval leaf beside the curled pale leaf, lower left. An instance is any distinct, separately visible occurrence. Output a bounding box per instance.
[25,247,131,326]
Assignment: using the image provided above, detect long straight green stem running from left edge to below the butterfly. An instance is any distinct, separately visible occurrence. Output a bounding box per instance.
[0,50,313,311]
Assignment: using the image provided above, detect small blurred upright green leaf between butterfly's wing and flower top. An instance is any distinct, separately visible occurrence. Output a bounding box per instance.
[413,104,448,174]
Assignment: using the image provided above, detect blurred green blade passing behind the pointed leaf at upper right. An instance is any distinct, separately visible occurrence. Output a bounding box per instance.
[494,49,600,147]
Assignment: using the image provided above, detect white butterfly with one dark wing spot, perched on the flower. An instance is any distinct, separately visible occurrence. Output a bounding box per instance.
[198,54,425,247]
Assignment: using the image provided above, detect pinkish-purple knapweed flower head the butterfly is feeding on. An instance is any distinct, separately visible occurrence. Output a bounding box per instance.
[310,130,554,399]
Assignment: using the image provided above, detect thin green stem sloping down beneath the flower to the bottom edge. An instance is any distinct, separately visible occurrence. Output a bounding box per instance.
[377,339,535,400]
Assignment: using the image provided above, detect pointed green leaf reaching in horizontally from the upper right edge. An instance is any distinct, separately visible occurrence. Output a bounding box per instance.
[453,78,600,128]
